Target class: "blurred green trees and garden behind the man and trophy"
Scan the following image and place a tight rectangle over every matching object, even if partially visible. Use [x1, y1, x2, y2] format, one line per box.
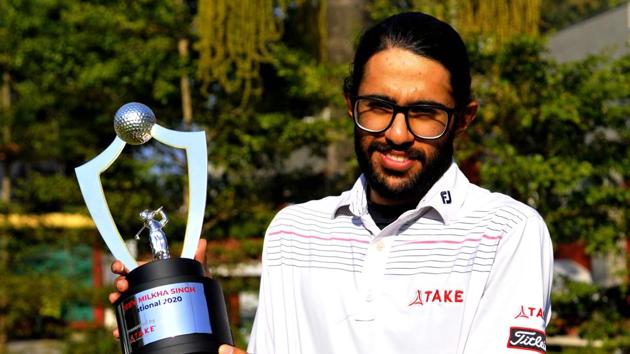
[0, 0, 630, 353]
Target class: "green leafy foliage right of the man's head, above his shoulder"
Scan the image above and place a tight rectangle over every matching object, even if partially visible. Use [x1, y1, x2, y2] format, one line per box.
[468, 38, 630, 251]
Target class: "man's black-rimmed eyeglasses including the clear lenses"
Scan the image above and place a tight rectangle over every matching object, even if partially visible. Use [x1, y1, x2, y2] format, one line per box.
[353, 96, 455, 139]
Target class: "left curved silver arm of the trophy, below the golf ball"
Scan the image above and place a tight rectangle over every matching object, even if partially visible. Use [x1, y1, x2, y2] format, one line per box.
[74, 137, 138, 271]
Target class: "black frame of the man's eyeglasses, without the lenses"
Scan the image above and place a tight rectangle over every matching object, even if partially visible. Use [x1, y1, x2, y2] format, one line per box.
[352, 96, 457, 140]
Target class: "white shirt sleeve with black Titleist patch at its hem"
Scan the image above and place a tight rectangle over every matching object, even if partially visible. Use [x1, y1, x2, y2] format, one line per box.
[463, 213, 553, 354]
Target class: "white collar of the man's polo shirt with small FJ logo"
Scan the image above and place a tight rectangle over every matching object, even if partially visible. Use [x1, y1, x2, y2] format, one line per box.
[331, 161, 470, 224]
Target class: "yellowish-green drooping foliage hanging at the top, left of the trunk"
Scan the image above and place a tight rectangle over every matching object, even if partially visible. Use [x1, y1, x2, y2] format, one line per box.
[196, 0, 326, 106]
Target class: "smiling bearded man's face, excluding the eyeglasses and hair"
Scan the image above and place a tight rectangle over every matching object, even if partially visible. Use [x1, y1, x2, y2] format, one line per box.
[349, 48, 455, 204]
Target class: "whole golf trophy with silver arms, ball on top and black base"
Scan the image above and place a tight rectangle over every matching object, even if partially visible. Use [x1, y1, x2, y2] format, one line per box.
[75, 102, 233, 354]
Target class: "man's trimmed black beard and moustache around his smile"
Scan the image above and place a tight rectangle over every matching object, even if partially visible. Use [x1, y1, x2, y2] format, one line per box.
[354, 128, 454, 202]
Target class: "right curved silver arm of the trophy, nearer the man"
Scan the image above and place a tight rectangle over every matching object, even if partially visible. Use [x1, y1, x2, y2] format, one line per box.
[151, 124, 208, 259]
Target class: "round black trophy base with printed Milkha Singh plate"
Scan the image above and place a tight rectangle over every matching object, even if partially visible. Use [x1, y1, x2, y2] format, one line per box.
[114, 258, 233, 354]
